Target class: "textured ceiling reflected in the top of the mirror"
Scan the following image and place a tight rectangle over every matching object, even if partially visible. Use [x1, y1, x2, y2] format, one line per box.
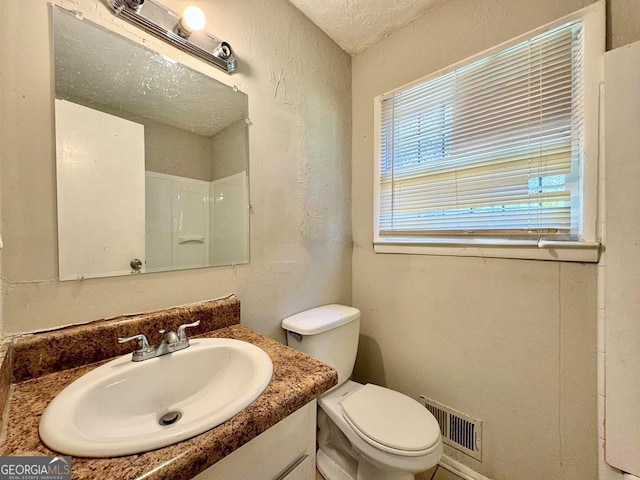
[54, 8, 248, 137]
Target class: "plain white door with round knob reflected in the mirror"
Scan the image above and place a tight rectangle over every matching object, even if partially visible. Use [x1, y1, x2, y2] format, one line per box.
[55, 99, 145, 280]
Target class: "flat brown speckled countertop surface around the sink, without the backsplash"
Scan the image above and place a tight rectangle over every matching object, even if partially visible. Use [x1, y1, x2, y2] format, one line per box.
[0, 297, 337, 480]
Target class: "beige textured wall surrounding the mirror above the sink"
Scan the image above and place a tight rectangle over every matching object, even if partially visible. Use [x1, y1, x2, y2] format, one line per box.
[0, 0, 351, 340]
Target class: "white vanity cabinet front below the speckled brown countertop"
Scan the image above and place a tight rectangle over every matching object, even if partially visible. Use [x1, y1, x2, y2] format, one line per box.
[194, 400, 316, 480]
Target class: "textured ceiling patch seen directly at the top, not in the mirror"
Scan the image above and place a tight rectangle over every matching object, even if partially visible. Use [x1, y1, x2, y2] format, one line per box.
[289, 0, 445, 55]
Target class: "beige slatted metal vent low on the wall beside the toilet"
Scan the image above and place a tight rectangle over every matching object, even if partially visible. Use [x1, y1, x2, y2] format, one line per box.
[420, 395, 482, 461]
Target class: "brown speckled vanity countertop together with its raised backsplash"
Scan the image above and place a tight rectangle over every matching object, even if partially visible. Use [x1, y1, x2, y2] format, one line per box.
[0, 297, 337, 480]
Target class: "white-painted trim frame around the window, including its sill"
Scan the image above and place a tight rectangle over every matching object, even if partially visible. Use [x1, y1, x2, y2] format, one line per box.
[373, 0, 605, 262]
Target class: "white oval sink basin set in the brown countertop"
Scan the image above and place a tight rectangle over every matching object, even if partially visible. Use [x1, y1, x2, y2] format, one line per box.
[40, 338, 273, 457]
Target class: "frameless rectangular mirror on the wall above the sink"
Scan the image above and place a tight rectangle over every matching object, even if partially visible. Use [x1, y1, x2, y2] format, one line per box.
[52, 6, 249, 280]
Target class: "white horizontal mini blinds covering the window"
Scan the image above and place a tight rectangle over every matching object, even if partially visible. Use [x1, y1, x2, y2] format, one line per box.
[378, 21, 584, 240]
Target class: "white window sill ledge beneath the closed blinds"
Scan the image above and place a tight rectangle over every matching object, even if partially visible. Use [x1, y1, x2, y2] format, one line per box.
[373, 238, 600, 263]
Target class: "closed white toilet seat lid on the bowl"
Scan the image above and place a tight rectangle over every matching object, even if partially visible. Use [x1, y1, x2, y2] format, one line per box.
[342, 383, 440, 455]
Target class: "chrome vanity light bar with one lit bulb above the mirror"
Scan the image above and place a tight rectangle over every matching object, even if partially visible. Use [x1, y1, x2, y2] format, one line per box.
[106, 0, 238, 73]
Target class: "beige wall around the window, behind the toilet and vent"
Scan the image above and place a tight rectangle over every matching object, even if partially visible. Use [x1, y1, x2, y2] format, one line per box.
[352, 0, 624, 480]
